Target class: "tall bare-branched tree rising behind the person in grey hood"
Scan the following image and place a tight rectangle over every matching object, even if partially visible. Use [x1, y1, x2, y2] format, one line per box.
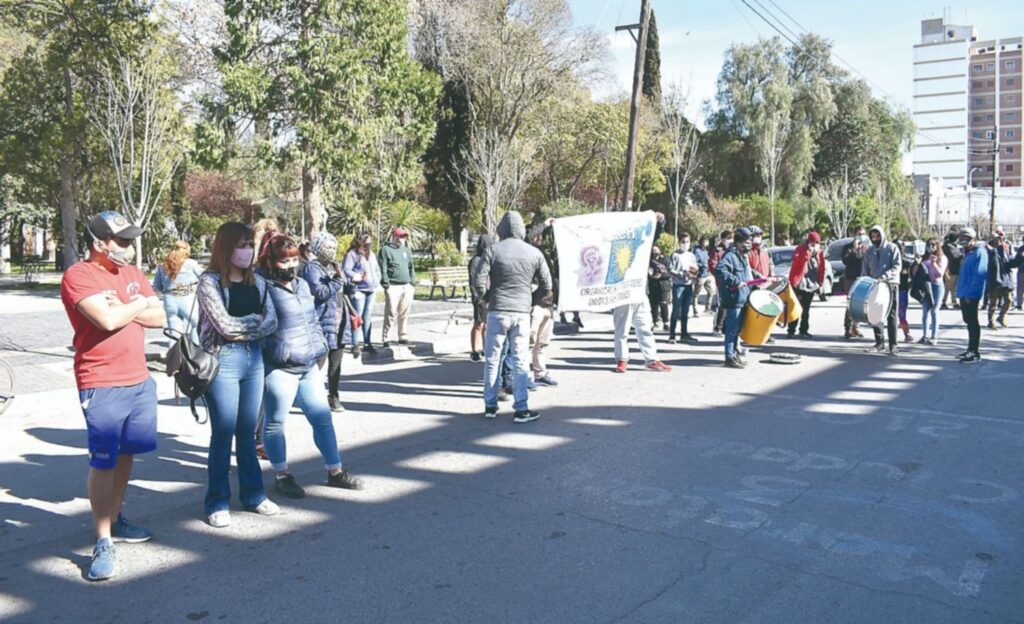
[415, 0, 604, 234]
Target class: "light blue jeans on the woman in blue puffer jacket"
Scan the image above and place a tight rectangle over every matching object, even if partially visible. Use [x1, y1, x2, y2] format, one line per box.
[263, 365, 341, 472]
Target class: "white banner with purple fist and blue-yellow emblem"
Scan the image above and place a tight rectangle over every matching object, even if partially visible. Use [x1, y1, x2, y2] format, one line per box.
[554, 211, 655, 311]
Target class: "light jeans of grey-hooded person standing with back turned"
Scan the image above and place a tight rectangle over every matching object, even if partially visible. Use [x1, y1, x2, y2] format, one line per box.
[483, 311, 529, 411]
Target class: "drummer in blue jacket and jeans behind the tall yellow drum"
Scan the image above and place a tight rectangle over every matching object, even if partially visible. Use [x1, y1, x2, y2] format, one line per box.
[715, 227, 754, 368]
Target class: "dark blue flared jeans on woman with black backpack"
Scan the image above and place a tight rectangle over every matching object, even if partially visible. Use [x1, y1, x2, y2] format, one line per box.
[205, 342, 266, 515]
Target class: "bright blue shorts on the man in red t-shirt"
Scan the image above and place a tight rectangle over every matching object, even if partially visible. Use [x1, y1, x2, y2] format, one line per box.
[78, 377, 157, 470]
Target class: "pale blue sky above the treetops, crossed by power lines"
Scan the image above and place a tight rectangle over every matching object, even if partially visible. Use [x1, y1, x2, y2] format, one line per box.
[568, 0, 1024, 125]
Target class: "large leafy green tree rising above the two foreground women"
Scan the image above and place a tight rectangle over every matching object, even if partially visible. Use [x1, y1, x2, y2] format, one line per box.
[217, 0, 438, 237]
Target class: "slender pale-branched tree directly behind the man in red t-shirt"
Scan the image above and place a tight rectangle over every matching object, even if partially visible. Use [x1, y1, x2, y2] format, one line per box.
[88, 49, 184, 267]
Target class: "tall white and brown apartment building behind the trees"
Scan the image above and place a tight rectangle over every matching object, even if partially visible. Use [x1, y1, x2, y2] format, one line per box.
[912, 18, 1024, 188]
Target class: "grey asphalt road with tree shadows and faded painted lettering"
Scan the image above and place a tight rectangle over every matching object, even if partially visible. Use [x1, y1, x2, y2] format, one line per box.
[0, 301, 1024, 623]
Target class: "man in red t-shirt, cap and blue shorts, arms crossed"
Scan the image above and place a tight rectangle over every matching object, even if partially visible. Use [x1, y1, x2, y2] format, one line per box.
[60, 211, 166, 581]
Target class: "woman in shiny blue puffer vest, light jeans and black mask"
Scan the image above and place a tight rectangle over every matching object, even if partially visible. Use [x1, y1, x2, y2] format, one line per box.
[260, 233, 359, 498]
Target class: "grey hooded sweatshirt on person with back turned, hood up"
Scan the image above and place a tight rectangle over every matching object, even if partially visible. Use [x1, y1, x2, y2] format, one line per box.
[472, 210, 551, 315]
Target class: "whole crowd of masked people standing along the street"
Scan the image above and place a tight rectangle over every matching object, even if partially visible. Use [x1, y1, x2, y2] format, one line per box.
[61, 211, 1024, 580]
